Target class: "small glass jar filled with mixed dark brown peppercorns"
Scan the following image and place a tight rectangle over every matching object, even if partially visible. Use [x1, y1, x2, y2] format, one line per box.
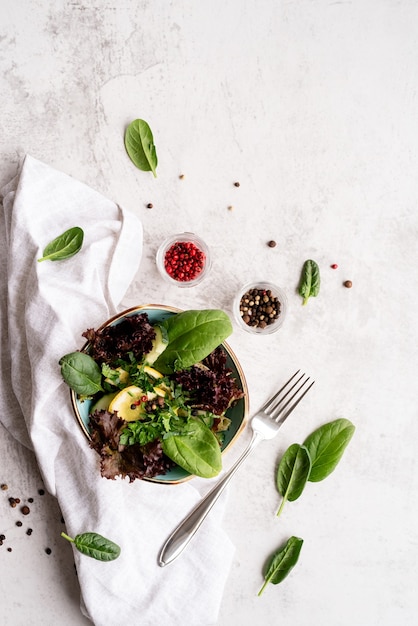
[233, 280, 288, 335]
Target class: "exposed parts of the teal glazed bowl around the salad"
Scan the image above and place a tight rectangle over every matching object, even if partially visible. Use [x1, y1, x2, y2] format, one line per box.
[71, 304, 249, 485]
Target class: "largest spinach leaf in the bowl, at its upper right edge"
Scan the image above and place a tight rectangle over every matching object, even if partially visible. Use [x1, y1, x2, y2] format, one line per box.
[153, 309, 232, 374]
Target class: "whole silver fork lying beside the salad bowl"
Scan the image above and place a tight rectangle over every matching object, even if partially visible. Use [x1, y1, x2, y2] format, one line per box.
[158, 370, 315, 567]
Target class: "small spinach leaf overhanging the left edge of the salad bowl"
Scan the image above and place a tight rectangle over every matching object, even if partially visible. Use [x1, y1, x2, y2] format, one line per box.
[59, 352, 104, 396]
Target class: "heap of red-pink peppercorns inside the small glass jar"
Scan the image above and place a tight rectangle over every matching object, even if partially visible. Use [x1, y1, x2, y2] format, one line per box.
[164, 241, 206, 282]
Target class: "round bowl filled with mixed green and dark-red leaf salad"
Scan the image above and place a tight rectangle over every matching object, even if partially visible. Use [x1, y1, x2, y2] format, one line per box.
[60, 304, 248, 484]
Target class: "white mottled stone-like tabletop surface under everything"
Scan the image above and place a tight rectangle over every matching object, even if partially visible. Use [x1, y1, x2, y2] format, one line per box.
[0, 0, 418, 626]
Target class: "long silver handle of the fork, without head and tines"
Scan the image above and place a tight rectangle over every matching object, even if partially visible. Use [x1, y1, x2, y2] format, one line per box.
[158, 433, 264, 567]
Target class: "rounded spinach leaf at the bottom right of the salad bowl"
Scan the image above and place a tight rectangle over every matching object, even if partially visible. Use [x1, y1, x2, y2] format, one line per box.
[162, 419, 222, 478]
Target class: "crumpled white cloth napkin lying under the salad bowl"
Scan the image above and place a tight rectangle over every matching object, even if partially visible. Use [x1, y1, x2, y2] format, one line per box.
[0, 156, 233, 626]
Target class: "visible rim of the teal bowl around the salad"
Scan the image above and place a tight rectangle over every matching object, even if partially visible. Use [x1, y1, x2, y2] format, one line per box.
[70, 304, 249, 485]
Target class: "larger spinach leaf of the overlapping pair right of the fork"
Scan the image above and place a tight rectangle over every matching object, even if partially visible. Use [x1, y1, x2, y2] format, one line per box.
[303, 418, 355, 482]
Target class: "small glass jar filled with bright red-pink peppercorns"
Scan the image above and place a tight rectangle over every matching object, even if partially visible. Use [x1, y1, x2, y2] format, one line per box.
[157, 233, 210, 287]
